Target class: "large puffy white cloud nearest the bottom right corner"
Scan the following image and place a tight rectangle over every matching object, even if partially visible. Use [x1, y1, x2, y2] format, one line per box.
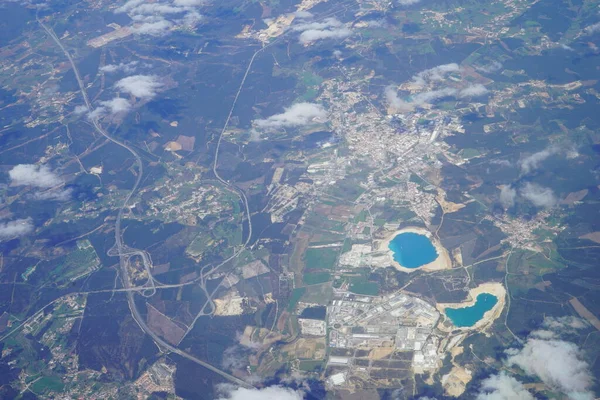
[506, 335, 593, 400]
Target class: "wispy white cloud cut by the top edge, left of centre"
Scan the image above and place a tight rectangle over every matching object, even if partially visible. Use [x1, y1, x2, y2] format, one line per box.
[115, 0, 205, 36]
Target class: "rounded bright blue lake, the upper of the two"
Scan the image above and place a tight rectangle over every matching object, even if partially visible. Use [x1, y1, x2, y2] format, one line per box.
[388, 232, 438, 268]
